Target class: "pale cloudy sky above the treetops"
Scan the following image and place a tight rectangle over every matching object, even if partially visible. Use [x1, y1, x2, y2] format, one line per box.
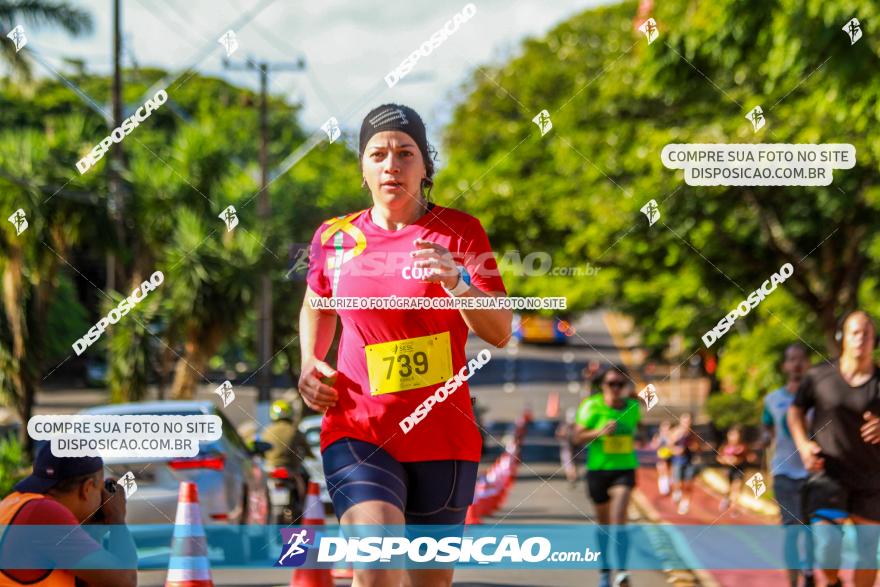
[20, 0, 607, 154]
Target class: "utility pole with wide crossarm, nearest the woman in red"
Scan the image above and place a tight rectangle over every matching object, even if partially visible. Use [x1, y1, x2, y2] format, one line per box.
[223, 58, 305, 425]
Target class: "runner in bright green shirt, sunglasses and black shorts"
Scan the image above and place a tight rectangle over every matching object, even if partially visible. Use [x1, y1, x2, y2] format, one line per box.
[572, 367, 641, 587]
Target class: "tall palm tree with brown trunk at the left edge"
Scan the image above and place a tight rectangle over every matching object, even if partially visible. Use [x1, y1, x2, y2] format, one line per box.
[0, 116, 101, 454]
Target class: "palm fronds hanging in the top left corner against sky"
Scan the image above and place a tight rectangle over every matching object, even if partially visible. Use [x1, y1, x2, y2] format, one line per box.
[0, 0, 92, 78]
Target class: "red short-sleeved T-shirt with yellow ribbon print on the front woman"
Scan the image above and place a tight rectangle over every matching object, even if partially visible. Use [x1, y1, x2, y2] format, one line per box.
[308, 206, 506, 462]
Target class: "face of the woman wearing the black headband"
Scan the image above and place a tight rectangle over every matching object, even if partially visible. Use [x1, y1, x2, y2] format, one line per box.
[362, 131, 426, 210]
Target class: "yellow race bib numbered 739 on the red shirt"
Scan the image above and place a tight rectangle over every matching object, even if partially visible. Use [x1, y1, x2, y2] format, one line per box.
[364, 332, 452, 395]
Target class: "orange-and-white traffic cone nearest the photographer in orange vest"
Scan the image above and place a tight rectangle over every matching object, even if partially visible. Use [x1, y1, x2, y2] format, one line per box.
[165, 481, 214, 587]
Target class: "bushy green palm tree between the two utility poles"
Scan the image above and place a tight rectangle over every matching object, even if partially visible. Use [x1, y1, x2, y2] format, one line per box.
[108, 120, 266, 401]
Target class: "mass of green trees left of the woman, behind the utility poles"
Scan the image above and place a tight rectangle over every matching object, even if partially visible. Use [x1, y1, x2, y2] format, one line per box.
[0, 62, 369, 414]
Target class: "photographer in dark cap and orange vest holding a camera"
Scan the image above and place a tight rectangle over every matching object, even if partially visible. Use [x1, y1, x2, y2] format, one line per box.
[0, 443, 137, 587]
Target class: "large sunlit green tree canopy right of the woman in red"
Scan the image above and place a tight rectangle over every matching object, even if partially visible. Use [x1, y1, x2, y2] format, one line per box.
[438, 0, 880, 395]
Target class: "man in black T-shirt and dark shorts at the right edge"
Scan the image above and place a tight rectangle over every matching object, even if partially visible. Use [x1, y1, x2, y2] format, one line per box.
[788, 311, 880, 587]
